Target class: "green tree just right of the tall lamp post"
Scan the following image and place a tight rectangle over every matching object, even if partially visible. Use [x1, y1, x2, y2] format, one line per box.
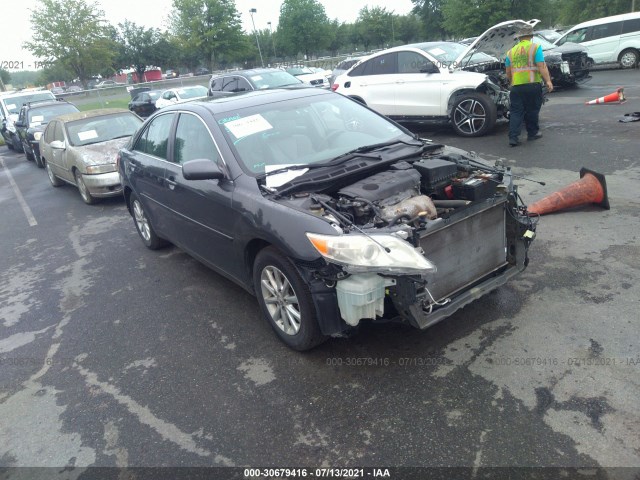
[278, 0, 330, 58]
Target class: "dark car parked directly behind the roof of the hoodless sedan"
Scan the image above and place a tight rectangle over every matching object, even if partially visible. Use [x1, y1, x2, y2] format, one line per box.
[208, 68, 308, 97]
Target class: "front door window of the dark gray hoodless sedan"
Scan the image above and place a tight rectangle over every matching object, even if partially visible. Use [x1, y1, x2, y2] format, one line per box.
[173, 113, 222, 167]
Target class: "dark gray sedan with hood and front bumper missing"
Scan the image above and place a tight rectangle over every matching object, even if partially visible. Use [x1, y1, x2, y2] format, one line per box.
[119, 88, 535, 350]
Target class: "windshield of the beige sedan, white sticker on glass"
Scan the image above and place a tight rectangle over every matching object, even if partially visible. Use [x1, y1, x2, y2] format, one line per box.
[65, 112, 142, 147]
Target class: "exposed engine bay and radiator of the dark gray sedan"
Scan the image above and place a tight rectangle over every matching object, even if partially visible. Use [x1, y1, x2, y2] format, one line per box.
[268, 145, 535, 334]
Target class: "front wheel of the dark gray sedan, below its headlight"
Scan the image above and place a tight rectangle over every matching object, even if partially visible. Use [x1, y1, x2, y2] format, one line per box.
[253, 247, 327, 351]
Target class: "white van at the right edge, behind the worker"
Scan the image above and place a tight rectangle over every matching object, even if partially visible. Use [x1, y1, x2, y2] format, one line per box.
[555, 12, 640, 68]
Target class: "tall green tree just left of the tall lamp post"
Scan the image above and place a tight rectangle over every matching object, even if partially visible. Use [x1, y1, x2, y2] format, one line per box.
[169, 0, 249, 69]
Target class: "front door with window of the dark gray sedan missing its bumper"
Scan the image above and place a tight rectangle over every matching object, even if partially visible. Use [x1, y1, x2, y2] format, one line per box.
[165, 112, 242, 278]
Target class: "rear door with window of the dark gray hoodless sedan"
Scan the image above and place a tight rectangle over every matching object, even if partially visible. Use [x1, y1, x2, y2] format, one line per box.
[124, 112, 177, 233]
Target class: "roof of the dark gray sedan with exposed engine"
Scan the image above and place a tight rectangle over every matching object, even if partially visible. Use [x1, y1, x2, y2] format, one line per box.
[161, 88, 340, 115]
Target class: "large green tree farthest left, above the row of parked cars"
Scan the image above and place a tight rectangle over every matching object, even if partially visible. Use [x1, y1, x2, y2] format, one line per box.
[24, 0, 116, 85]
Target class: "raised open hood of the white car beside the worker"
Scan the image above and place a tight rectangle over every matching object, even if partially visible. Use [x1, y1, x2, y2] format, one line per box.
[455, 19, 540, 69]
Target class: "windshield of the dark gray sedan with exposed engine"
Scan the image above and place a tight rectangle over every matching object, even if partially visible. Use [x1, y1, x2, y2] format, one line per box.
[216, 94, 415, 176]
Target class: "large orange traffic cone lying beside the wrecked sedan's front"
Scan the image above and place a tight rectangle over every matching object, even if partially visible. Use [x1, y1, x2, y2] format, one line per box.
[527, 168, 609, 215]
